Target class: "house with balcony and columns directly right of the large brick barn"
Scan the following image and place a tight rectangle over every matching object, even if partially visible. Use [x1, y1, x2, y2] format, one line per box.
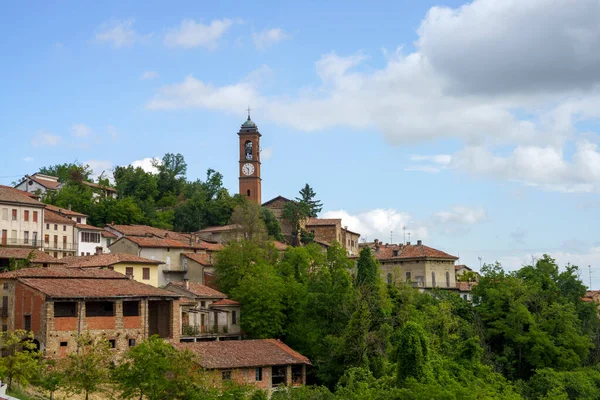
[165, 280, 242, 342]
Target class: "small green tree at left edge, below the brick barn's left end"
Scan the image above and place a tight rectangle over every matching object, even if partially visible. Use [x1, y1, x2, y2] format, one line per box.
[0, 329, 41, 388]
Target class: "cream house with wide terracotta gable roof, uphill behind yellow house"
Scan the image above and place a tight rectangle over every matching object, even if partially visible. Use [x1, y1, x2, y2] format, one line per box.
[110, 232, 223, 286]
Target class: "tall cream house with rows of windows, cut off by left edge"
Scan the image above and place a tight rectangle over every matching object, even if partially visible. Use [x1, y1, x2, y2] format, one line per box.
[0, 185, 45, 249]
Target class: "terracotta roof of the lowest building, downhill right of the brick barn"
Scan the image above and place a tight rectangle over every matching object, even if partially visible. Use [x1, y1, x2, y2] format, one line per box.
[173, 339, 310, 369]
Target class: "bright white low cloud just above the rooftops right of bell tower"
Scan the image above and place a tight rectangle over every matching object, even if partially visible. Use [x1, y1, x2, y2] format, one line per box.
[320, 208, 429, 243]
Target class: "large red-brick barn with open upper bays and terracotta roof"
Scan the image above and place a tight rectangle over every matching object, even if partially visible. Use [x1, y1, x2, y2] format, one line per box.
[0, 267, 179, 357]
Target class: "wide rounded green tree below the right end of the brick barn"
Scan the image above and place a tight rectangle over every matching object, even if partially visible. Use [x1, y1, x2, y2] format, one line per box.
[113, 336, 197, 400]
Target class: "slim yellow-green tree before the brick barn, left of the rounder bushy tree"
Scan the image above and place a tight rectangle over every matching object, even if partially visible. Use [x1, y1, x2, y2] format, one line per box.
[65, 333, 112, 400]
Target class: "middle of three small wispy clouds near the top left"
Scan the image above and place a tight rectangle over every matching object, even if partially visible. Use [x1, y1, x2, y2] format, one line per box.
[164, 19, 234, 49]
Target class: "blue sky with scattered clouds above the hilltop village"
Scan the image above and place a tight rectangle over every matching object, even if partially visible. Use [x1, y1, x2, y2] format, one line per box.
[0, 0, 600, 289]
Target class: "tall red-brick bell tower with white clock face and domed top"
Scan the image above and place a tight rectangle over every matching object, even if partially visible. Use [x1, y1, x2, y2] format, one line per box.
[238, 108, 262, 205]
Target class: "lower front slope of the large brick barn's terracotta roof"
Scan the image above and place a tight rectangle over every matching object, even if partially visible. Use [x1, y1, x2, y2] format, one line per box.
[19, 275, 179, 299]
